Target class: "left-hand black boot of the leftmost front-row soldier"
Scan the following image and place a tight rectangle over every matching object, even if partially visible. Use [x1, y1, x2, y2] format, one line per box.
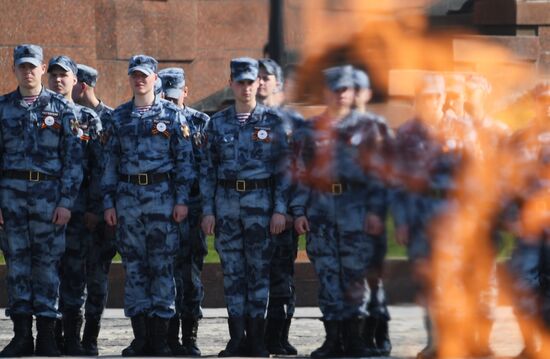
[0, 315, 34, 358]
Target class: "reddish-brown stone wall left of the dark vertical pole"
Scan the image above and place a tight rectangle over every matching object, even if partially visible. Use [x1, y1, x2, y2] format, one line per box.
[0, 0, 269, 105]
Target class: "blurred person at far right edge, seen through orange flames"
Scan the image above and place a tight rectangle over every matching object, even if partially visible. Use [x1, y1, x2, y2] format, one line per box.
[508, 82, 550, 359]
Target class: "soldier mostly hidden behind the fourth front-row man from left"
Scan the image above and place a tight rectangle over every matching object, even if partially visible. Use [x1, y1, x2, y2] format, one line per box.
[353, 69, 393, 356]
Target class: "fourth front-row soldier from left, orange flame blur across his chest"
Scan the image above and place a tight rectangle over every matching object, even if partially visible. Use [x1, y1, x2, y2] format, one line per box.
[293, 65, 385, 358]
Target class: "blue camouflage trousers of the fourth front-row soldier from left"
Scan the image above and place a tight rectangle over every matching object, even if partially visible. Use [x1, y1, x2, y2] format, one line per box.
[306, 191, 373, 320]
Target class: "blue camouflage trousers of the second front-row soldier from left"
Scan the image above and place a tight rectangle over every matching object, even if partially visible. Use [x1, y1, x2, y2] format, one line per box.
[116, 181, 179, 319]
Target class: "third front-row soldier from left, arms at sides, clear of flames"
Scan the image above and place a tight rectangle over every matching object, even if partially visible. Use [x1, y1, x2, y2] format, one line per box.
[200, 57, 290, 357]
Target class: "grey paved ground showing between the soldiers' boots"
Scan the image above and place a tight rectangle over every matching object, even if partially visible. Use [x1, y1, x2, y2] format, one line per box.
[0, 306, 522, 358]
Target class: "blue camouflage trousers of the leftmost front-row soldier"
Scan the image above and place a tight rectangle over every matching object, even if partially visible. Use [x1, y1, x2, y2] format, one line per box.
[0, 179, 65, 318]
